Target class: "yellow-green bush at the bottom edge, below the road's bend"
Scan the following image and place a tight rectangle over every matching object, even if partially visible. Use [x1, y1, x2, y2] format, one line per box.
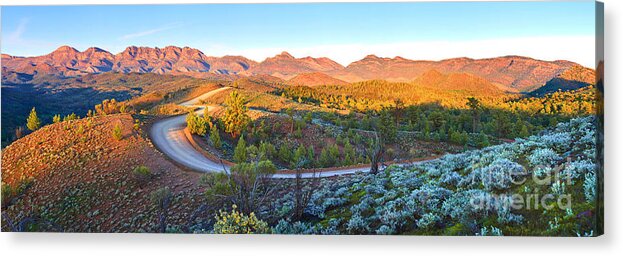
[214, 205, 270, 234]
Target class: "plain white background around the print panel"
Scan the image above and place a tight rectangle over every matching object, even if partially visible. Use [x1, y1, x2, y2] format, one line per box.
[0, 0, 623, 256]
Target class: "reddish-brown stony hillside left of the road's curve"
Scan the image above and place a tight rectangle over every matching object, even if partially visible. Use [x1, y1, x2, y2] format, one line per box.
[2, 115, 202, 232]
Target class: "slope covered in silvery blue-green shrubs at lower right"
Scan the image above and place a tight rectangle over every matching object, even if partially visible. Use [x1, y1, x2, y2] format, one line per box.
[265, 117, 603, 237]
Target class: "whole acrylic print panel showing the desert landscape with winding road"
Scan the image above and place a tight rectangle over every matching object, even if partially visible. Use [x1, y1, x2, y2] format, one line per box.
[1, 1, 604, 236]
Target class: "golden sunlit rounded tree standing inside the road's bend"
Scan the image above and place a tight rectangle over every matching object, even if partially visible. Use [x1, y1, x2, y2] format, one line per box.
[223, 91, 250, 138]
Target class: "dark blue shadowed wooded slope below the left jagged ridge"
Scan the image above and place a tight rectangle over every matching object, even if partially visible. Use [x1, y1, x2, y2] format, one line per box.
[1, 72, 219, 146]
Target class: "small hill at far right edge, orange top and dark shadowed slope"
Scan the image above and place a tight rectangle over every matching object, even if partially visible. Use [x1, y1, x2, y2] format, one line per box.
[530, 65, 596, 96]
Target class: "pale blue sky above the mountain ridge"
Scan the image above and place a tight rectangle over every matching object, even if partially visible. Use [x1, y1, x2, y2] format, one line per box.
[0, 1, 595, 67]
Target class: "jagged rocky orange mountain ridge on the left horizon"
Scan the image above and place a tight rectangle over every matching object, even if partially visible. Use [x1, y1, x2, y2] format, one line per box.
[2, 46, 256, 80]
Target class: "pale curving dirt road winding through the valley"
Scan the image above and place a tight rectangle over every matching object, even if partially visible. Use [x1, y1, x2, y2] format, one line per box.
[149, 87, 430, 179]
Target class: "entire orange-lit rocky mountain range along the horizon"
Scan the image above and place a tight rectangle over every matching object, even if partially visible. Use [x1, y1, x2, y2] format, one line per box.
[1, 46, 594, 92]
